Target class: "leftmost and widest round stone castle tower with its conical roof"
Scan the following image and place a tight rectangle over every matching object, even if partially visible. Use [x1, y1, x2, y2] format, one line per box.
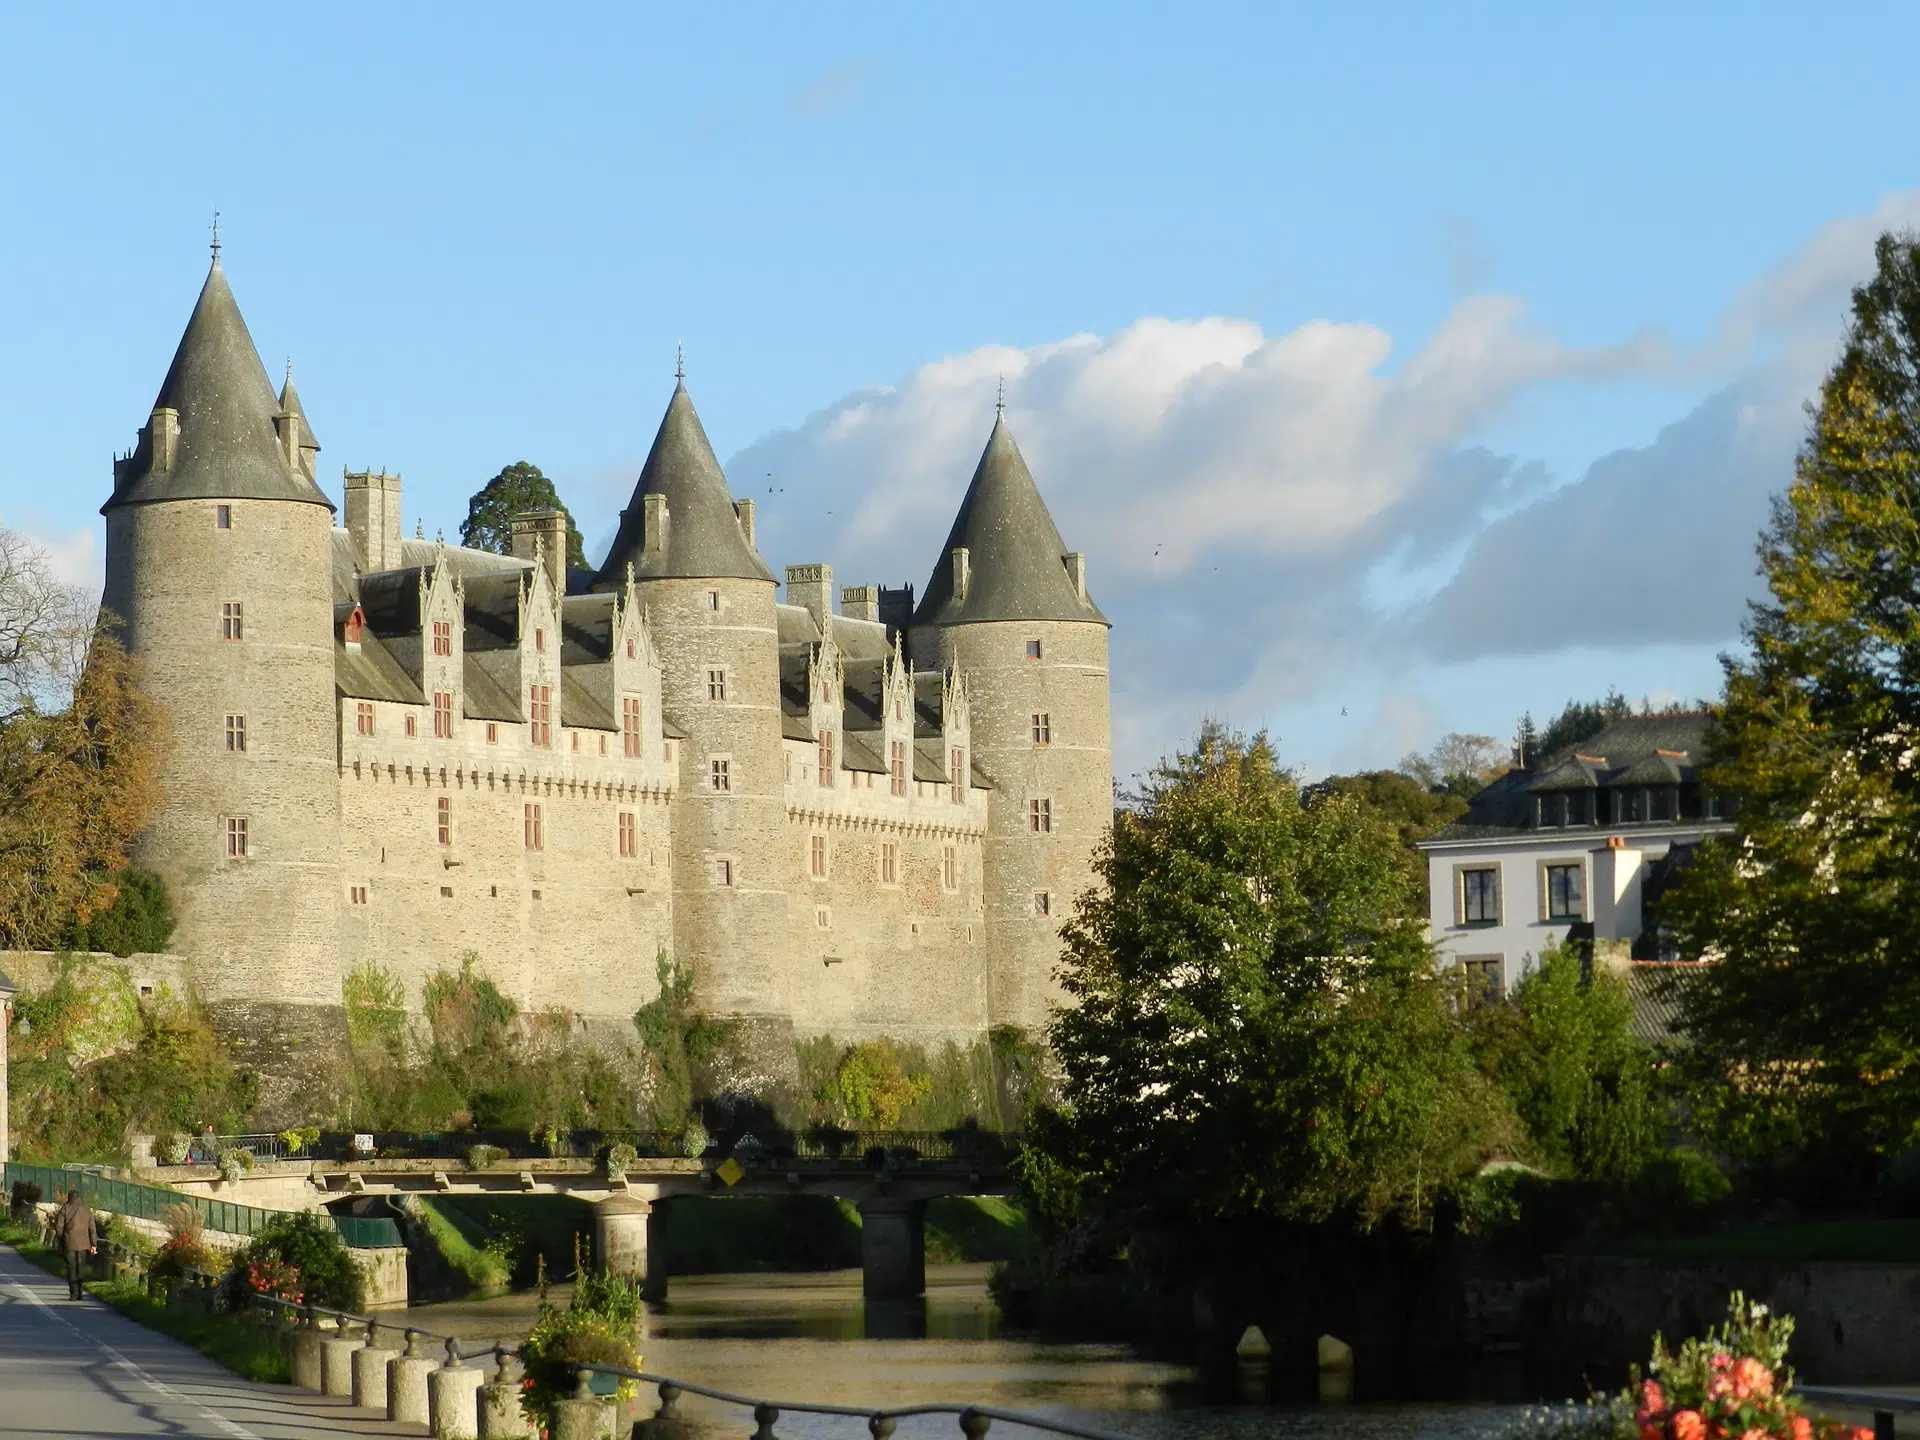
[102, 248, 340, 1119]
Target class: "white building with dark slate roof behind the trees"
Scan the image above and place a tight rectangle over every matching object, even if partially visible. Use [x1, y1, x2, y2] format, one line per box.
[1421, 712, 1732, 996]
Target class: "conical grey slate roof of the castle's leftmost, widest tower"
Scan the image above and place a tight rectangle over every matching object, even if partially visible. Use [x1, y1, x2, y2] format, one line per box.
[100, 257, 334, 511]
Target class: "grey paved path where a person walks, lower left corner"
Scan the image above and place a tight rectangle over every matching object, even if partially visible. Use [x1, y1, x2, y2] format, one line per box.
[0, 1246, 426, 1440]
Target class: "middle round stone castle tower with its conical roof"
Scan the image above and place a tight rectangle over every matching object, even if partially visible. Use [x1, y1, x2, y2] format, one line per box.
[593, 382, 791, 1066]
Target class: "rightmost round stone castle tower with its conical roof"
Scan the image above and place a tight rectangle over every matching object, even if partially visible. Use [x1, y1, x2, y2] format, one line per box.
[910, 415, 1114, 1031]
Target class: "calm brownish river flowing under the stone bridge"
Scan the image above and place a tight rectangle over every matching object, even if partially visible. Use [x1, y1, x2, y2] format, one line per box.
[396, 1265, 1517, 1440]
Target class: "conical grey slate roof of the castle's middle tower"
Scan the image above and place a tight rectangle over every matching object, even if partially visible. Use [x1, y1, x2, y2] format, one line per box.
[593, 382, 774, 586]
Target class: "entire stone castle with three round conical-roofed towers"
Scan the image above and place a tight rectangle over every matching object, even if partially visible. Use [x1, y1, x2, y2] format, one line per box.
[102, 248, 1112, 1110]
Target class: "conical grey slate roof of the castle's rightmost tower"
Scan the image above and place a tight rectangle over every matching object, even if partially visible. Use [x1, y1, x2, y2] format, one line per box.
[912, 415, 1108, 626]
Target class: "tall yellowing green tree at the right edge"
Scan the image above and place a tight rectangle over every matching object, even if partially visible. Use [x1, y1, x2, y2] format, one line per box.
[1663, 234, 1920, 1183]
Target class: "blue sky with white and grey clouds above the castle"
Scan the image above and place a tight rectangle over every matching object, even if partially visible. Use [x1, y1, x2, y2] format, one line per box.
[0, 4, 1920, 780]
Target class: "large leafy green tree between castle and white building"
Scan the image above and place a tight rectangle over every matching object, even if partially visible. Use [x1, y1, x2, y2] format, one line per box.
[1025, 724, 1513, 1229]
